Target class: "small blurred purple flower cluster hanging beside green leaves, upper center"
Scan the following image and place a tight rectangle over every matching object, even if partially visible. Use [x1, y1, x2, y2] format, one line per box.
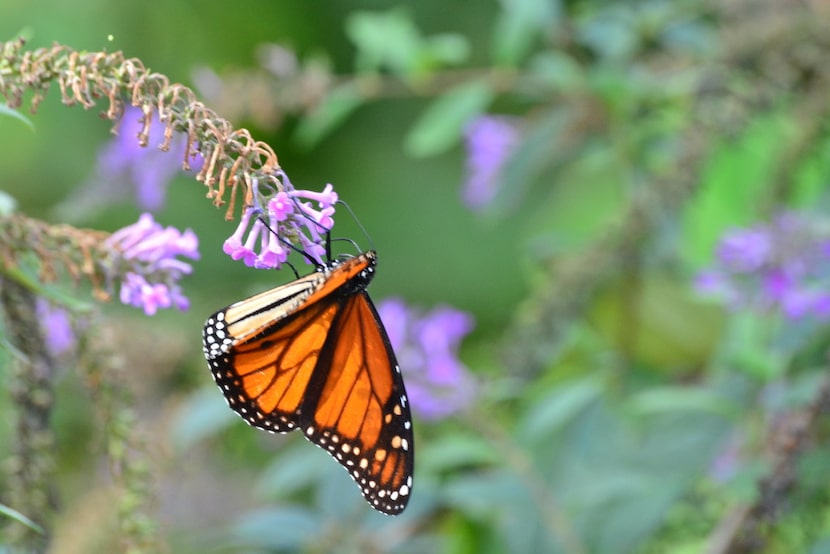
[462, 116, 519, 210]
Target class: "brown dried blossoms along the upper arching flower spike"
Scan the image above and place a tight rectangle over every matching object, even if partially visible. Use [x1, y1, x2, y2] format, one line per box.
[0, 39, 281, 219]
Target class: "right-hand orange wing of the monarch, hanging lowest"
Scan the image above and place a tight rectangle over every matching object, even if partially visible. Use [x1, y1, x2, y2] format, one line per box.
[302, 291, 414, 514]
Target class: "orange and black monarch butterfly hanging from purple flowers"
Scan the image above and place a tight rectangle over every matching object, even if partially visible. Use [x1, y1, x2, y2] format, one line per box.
[202, 250, 414, 515]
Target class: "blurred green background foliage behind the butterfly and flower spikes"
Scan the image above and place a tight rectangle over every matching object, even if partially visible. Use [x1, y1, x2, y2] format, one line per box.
[0, 0, 830, 553]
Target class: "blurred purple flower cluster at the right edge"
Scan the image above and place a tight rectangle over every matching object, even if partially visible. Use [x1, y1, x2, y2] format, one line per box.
[696, 212, 830, 320]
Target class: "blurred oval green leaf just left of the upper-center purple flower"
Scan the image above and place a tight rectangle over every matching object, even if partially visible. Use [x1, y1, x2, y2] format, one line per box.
[404, 81, 493, 157]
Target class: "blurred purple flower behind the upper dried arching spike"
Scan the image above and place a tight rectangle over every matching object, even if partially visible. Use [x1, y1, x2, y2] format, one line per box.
[72, 106, 203, 215]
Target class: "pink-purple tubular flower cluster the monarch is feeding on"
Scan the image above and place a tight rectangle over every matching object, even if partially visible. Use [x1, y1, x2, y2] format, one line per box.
[223, 170, 337, 269]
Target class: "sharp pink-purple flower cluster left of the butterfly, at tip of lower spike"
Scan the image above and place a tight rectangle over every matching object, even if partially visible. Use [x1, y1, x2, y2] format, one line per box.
[106, 213, 199, 315]
